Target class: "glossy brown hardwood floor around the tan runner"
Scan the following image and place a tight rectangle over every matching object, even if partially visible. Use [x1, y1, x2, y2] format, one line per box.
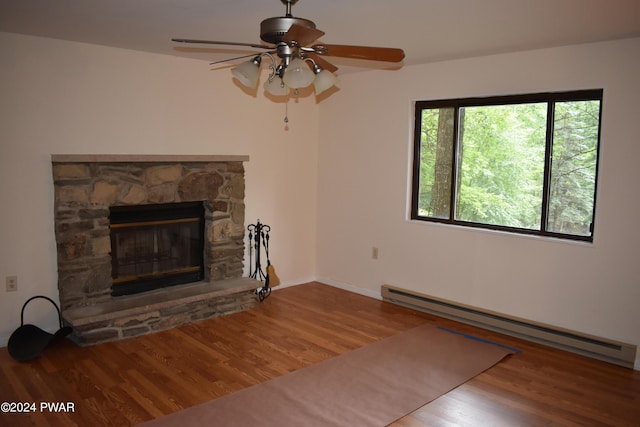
[0, 283, 640, 427]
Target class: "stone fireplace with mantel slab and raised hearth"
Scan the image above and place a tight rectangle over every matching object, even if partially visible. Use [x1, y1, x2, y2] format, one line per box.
[52, 155, 259, 344]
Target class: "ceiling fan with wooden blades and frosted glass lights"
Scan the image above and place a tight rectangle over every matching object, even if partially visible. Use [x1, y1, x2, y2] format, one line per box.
[171, 0, 404, 95]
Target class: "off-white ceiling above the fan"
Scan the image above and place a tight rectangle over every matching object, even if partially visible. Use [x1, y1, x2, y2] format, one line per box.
[0, 0, 640, 73]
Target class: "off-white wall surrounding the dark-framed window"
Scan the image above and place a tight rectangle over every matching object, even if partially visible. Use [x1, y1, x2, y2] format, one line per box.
[318, 39, 640, 368]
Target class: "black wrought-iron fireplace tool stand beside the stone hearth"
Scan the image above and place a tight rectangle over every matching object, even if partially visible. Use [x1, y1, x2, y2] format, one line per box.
[247, 219, 280, 301]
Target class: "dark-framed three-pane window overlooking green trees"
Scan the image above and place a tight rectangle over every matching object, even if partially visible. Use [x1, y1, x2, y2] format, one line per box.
[411, 89, 602, 241]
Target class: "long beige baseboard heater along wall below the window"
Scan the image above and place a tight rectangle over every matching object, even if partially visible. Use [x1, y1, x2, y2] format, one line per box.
[381, 285, 637, 369]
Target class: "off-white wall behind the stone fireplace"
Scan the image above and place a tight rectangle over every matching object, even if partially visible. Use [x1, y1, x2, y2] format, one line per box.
[0, 33, 317, 345]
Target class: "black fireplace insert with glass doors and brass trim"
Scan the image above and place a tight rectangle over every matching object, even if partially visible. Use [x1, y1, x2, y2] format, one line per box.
[109, 202, 204, 296]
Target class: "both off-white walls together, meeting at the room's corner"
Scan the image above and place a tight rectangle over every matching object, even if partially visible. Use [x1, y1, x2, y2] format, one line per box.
[0, 33, 640, 368]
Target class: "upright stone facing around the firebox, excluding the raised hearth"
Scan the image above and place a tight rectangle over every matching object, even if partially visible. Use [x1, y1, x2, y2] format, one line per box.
[52, 155, 248, 312]
